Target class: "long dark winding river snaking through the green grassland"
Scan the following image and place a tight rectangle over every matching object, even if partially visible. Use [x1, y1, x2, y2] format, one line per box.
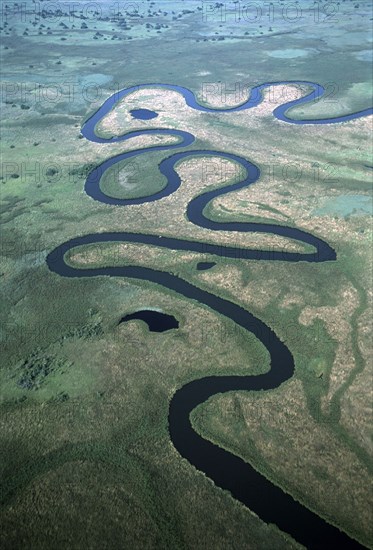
[47, 82, 372, 548]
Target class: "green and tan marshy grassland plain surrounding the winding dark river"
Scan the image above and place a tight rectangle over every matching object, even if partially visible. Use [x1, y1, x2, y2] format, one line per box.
[0, 2, 372, 550]
